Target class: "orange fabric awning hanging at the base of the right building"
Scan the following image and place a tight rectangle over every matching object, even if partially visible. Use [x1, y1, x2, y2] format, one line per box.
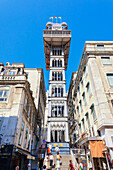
[89, 141, 105, 158]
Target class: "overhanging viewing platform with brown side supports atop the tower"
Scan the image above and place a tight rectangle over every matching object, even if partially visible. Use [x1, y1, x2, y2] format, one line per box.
[43, 22, 71, 70]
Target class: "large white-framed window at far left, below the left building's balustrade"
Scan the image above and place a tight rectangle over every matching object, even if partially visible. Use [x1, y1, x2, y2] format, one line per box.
[0, 86, 9, 101]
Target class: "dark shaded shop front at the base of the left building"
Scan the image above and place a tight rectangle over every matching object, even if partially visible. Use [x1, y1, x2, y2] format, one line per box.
[0, 145, 35, 170]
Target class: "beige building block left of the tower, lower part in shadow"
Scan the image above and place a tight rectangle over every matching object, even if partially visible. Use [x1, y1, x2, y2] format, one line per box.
[0, 63, 46, 170]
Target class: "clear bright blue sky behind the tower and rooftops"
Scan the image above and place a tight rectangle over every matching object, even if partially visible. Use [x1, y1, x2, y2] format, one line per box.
[0, 0, 113, 90]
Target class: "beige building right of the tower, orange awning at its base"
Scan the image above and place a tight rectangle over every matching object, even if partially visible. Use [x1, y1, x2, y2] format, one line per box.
[69, 41, 113, 169]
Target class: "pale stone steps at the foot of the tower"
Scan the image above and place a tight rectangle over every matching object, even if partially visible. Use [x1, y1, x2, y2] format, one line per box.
[54, 155, 72, 170]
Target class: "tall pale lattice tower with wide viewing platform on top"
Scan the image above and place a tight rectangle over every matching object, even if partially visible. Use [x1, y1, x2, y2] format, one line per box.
[43, 22, 71, 149]
